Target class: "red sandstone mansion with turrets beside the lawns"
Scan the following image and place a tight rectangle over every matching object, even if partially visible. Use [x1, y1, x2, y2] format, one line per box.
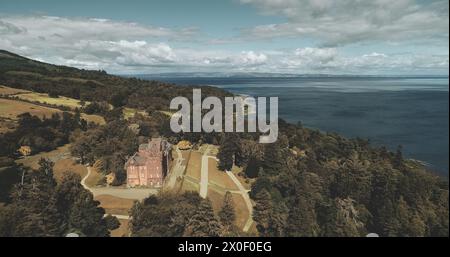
[125, 138, 171, 187]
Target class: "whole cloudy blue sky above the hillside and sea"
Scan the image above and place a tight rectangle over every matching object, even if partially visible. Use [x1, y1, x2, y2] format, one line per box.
[0, 0, 449, 75]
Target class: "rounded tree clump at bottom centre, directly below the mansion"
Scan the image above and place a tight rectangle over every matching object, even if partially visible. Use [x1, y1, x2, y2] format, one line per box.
[130, 192, 239, 237]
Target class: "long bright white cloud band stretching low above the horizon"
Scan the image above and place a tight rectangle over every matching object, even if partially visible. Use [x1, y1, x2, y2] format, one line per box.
[0, 14, 448, 74]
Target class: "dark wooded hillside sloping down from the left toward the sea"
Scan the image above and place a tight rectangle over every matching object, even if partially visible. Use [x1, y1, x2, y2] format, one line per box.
[0, 50, 229, 110]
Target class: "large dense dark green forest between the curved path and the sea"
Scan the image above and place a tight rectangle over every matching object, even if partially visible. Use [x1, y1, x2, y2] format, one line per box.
[246, 122, 449, 236]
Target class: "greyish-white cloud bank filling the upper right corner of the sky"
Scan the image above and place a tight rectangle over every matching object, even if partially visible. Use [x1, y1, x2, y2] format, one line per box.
[237, 0, 449, 46]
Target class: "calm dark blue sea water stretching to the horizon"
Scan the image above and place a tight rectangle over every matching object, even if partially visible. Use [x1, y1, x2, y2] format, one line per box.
[142, 77, 449, 176]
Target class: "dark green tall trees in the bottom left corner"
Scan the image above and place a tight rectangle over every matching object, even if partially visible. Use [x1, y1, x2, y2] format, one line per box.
[0, 159, 109, 236]
